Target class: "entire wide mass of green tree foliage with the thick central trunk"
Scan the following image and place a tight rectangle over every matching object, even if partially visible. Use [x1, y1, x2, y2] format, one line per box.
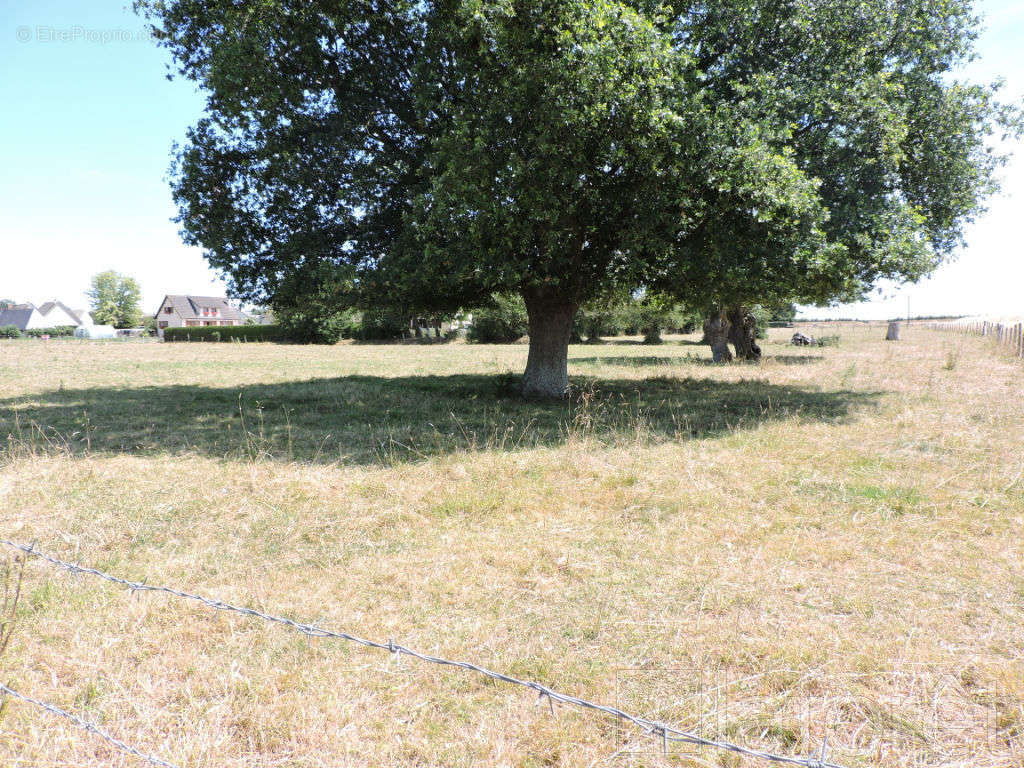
[137, 0, 1017, 395]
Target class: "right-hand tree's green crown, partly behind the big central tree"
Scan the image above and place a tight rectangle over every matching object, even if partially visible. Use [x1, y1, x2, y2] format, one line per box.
[647, 0, 1020, 315]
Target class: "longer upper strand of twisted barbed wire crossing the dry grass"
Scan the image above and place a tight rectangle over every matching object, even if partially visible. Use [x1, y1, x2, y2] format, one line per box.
[0, 539, 844, 768]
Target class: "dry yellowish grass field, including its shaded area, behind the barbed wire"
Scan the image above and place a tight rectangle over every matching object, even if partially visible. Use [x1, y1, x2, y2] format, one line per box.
[0, 325, 1024, 768]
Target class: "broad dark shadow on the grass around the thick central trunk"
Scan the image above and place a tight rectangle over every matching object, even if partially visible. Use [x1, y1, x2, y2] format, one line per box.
[0, 375, 879, 464]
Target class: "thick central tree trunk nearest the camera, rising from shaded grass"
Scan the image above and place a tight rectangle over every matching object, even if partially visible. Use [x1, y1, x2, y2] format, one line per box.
[522, 289, 577, 397]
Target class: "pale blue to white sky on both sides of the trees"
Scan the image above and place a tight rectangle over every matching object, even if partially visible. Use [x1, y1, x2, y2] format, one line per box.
[0, 0, 1024, 317]
